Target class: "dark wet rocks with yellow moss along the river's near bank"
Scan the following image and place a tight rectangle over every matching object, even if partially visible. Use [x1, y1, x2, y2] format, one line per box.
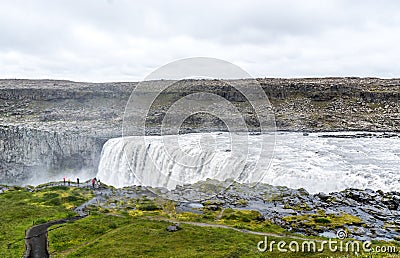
[164, 180, 400, 240]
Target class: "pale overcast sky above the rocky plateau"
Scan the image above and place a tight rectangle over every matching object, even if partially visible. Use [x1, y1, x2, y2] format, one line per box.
[0, 0, 400, 82]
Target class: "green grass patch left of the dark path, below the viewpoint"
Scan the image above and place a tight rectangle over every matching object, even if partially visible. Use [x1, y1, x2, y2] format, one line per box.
[0, 187, 91, 257]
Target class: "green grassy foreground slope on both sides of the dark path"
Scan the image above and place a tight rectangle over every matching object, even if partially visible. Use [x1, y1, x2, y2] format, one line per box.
[0, 187, 400, 257]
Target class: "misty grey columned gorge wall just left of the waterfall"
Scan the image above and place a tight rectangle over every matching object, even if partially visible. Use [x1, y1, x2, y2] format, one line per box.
[0, 126, 103, 184]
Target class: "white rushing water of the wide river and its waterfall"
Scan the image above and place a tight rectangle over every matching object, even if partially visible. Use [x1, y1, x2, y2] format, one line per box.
[97, 132, 400, 193]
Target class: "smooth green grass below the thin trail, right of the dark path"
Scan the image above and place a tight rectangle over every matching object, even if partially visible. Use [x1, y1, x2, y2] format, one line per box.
[49, 214, 400, 258]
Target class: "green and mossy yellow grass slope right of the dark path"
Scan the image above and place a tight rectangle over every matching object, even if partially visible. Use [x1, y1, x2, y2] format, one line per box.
[49, 200, 400, 257]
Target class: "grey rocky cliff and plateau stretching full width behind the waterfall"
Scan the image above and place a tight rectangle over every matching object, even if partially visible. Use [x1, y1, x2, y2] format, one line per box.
[0, 78, 400, 183]
